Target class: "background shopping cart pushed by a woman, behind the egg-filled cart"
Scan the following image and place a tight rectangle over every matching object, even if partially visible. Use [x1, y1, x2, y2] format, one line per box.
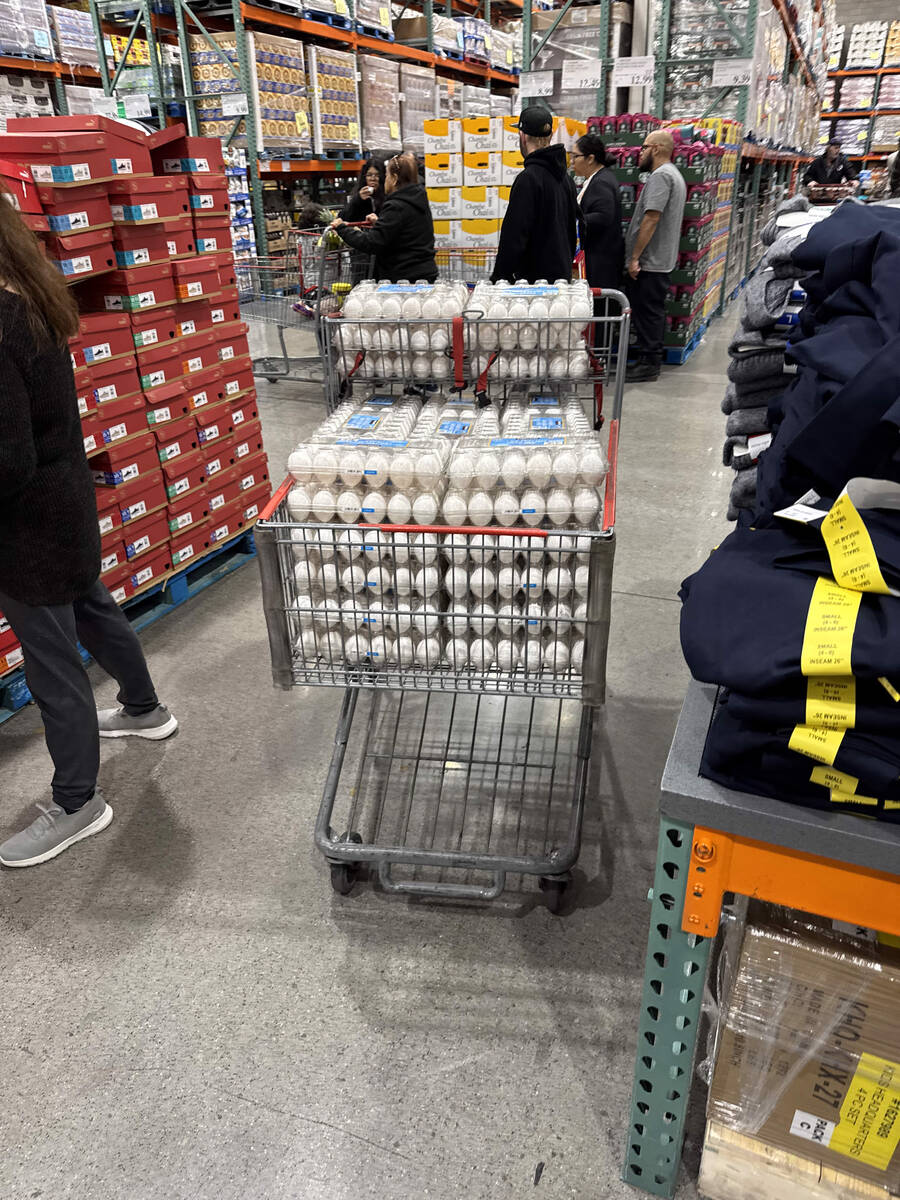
[236, 228, 371, 385]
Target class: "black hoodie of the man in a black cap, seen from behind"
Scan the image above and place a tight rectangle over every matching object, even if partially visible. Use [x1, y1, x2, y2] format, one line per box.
[491, 145, 578, 283]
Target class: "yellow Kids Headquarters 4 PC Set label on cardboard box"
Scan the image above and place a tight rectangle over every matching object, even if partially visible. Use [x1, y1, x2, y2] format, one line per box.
[829, 1054, 900, 1171]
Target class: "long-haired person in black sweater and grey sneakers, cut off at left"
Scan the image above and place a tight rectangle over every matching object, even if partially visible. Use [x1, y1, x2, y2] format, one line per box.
[0, 197, 178, 866]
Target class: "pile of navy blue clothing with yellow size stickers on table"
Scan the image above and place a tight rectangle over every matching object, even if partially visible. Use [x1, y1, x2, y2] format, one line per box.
[682, 204, 900, 822]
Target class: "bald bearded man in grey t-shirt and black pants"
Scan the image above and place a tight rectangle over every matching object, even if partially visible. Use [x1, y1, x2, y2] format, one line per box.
[625, 130, 688, 383]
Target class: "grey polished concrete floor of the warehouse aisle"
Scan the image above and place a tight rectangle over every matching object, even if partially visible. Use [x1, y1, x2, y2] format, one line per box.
[0, 319, 733, 1200]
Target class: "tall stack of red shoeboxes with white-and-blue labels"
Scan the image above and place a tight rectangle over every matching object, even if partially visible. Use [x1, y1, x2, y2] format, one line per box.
[0, 116, 270, 609]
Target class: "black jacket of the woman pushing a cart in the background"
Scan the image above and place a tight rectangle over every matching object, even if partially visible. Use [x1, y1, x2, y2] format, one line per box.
[337, 184, 438, 283]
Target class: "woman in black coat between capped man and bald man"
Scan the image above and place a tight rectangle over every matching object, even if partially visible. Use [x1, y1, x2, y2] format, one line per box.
[571, 133, 625, 288]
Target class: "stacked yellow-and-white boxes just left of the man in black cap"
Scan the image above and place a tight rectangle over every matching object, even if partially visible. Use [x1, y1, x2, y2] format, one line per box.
[425, 116, 522, 250]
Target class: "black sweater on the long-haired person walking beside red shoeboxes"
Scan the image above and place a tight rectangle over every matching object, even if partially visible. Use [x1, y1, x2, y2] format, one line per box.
[0, 288, 100, 606]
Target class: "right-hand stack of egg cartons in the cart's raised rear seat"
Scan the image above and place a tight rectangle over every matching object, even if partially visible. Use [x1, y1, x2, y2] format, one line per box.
[466, 280, 594, 383]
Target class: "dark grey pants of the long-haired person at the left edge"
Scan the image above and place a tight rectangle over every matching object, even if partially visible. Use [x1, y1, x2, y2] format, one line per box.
[0, 581, 158, 812]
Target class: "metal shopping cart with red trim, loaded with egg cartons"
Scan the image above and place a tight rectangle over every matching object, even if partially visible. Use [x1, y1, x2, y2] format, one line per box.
[257, 293, 630, 912]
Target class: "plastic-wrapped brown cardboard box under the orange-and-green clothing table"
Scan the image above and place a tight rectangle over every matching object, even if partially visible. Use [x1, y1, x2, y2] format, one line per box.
[709, 905, 900, 1190]
